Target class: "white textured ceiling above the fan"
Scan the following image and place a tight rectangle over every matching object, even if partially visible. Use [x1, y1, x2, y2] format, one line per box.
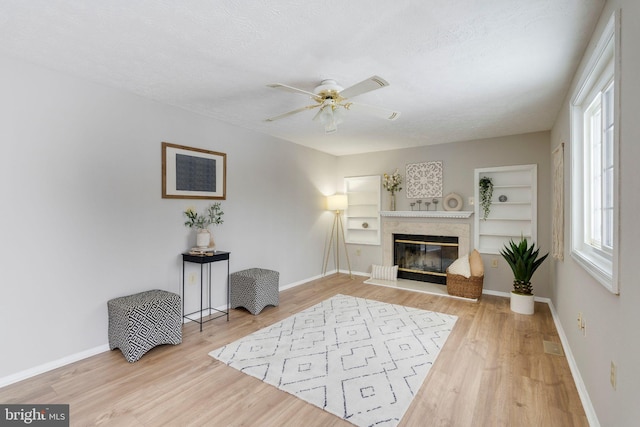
[0, 0, 604, 155]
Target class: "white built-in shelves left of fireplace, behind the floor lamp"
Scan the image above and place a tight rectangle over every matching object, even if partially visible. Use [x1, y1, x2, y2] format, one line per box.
[344, 175, 381, 245]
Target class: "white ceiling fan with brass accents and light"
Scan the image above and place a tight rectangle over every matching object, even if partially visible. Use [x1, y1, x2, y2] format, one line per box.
[266, 76, 400, 133]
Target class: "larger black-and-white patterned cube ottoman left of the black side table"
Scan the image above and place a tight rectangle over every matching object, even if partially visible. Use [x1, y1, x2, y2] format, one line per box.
[107, 289, 182, 362]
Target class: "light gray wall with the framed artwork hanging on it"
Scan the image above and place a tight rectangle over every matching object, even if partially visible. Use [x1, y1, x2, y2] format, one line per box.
[0, 57, 336, 379]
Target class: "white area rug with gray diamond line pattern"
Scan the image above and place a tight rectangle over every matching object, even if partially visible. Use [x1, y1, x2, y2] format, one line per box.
[209, 295, 457, 426]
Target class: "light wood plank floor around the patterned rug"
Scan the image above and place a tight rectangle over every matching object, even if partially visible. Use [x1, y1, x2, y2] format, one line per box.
[0, 275, 588, 427]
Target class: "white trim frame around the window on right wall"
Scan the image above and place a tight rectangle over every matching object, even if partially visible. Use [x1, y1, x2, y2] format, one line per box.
[570, 10, 620, 294]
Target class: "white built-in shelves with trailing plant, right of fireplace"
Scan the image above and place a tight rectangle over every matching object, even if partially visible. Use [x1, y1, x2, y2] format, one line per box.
[474, 165, 538, 254]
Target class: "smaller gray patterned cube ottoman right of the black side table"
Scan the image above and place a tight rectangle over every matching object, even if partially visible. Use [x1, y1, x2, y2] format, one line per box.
[231, 268, 280, 315]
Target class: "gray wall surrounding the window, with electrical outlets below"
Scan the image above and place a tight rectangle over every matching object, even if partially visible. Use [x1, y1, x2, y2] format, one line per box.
[550, 0, 640, 427]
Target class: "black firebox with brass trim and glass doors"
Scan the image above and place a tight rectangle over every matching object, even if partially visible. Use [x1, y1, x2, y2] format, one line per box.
[393, 234, 458, 285]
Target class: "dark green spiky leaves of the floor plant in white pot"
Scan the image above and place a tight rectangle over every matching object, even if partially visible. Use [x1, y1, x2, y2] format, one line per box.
[500, 237, 549, 295]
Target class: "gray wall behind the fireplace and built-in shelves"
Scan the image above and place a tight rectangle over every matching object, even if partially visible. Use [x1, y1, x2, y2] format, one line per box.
[337, 132, 551, 297]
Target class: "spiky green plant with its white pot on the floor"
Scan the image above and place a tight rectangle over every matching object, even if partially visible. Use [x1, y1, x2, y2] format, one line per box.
[500, 237, 549, 314]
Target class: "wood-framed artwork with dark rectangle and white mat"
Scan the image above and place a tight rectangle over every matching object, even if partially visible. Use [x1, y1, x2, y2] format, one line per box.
[162, 142, 227, 200]
